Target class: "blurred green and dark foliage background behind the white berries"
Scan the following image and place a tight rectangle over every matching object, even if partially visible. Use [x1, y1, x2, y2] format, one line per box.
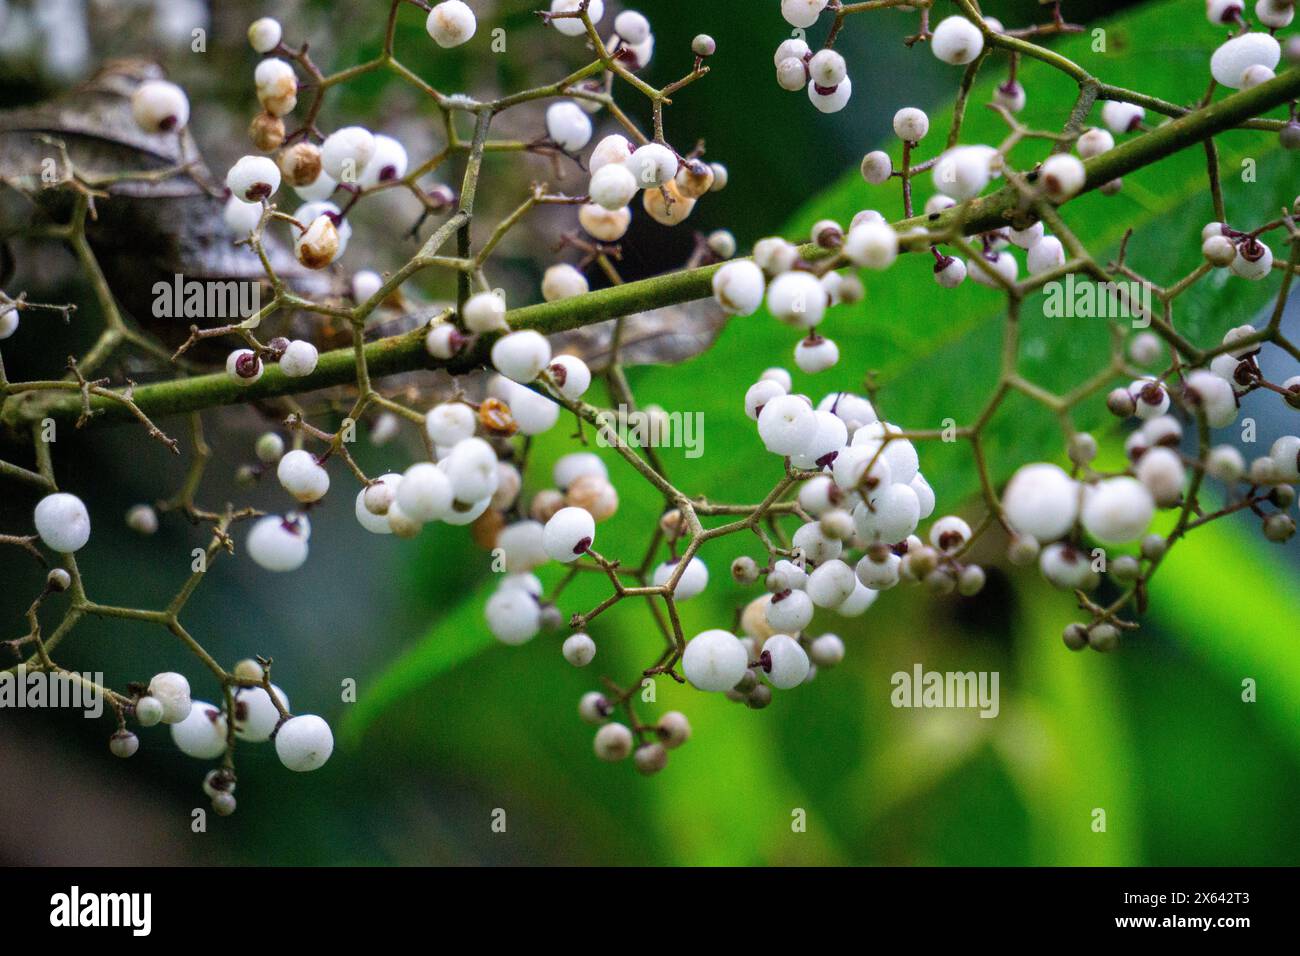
[0, 0, 1300, 865]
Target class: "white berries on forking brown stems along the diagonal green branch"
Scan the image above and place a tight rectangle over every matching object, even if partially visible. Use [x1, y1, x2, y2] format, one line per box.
[0, 0, 1300, 813]
